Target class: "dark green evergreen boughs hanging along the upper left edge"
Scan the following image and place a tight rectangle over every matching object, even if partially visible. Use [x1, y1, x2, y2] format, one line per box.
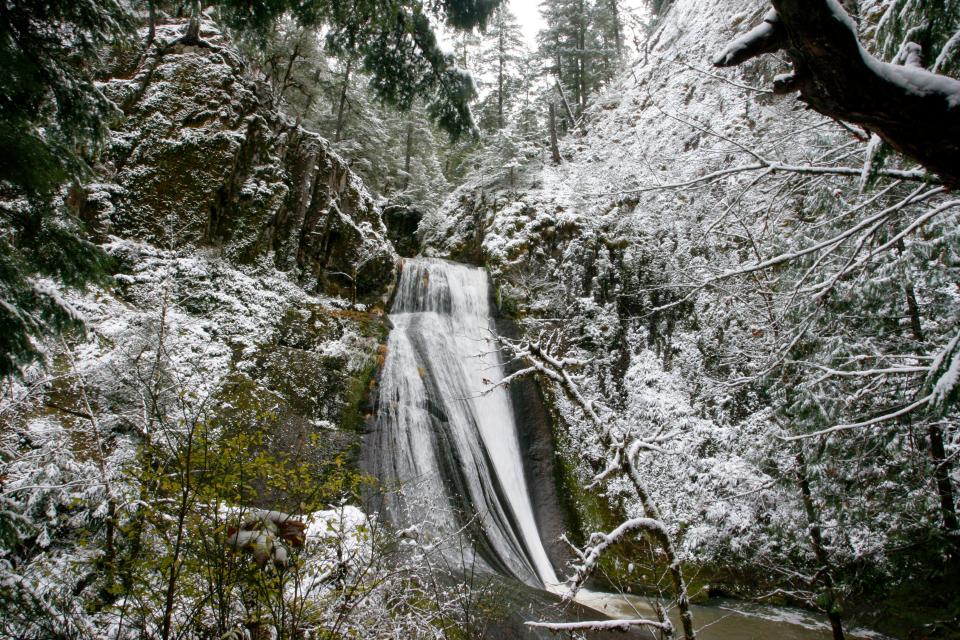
[0, 0, 130, 376]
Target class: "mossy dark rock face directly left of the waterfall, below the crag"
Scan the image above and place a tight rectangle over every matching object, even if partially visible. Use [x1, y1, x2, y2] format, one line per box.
[215, 304, 387, 508]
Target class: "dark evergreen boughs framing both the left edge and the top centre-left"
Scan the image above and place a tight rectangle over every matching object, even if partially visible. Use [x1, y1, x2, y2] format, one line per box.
[0, 0, 500, 376]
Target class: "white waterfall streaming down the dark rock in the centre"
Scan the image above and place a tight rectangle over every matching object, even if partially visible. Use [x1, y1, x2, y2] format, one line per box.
[369, 259, 558, 588]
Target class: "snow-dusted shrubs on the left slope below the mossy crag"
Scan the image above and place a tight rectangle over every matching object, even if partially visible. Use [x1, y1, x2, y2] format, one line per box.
[0, 238, 390, 637]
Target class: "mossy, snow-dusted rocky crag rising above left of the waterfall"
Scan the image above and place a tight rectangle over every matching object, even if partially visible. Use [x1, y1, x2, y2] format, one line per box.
[95, 23, 396, 301]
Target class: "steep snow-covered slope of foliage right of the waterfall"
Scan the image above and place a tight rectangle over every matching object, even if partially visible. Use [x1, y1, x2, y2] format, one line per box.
[420, 0, 960, 624]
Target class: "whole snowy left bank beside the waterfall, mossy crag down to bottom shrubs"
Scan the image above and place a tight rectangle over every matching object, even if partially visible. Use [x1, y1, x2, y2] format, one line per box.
[0, 16, 414, 639]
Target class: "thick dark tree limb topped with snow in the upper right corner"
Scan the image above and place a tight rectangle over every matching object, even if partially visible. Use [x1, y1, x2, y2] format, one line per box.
[714, 0, 960, 187]
